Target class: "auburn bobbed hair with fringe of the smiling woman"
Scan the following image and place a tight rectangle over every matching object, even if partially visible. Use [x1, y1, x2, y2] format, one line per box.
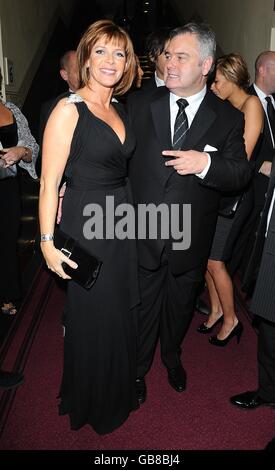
[76, 20, 136, 96]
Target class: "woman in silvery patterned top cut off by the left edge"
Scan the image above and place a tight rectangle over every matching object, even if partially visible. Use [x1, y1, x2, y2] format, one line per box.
[0, 70, 39, 315]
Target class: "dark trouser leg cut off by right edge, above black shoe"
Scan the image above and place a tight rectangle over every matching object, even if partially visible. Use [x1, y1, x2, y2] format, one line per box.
[258, 319, 275, 402]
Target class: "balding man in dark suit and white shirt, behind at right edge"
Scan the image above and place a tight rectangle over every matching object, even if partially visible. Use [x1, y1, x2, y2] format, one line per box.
[228, 51, 275, 280]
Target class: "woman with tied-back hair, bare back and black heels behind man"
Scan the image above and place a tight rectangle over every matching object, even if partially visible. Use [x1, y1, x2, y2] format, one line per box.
[198, 53, 264, 346]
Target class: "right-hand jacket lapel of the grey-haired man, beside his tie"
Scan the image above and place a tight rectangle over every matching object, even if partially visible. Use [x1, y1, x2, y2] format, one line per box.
[182, 92, 217, 150]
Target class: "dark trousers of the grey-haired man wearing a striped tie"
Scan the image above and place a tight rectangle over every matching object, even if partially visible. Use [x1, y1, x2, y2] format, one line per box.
[137, 252, 204, 377]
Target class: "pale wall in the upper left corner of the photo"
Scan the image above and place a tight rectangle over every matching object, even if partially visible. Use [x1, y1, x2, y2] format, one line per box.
[0, 0, 75, 104]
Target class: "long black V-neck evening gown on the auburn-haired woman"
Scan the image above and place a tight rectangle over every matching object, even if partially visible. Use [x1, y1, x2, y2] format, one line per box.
[59, 95, 139, 434]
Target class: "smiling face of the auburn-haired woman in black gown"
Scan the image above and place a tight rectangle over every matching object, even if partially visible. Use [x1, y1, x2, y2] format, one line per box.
[86, 36, 126, 88]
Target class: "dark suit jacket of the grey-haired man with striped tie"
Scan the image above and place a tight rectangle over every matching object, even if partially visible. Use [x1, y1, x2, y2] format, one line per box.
[128, 87, 251, 274]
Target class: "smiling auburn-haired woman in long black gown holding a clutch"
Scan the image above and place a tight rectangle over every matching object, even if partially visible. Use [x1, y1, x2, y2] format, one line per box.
[40, 20, 139, 434]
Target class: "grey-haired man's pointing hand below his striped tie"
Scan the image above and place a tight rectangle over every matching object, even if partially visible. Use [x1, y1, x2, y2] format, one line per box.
[162, 150, 208, 175]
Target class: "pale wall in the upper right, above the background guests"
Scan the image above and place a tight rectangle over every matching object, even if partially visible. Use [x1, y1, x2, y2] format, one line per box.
[171, 0, 275, 78]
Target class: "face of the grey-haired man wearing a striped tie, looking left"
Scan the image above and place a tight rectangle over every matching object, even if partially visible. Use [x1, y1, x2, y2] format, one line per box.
[164, 33, 212, 97]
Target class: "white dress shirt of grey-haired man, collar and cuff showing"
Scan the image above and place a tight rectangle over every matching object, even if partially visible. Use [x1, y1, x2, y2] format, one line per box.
[170, 85, 211, 179]
